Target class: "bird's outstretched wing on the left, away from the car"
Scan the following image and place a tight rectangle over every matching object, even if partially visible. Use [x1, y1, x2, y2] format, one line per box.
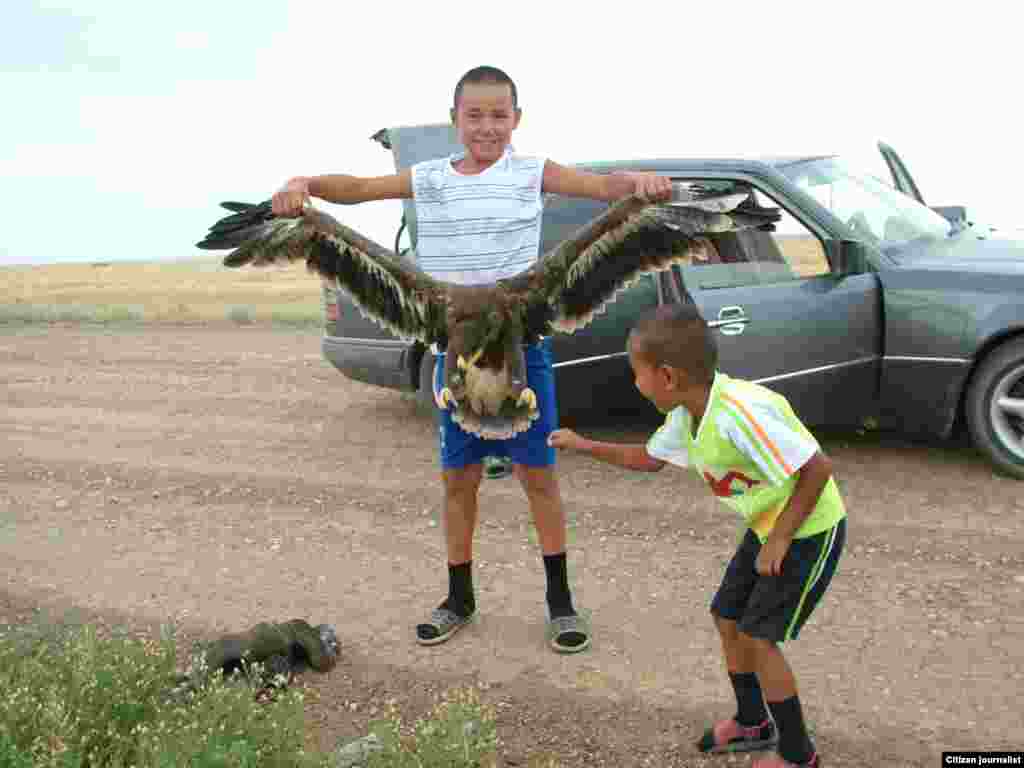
[197, 202, 445, 344]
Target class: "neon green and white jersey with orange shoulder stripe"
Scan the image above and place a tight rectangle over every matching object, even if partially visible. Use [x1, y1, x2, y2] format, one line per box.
[647, 373, 846, 542]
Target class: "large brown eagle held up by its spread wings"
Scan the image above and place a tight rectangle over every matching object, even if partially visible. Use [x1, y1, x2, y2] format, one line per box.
[197, 182, 779, 439]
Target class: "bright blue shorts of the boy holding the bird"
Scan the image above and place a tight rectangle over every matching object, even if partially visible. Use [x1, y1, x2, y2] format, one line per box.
[434, 339, 558, 469]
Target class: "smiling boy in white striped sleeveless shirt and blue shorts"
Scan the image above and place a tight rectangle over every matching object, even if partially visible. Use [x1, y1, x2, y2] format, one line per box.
[273, 67, 672, 652]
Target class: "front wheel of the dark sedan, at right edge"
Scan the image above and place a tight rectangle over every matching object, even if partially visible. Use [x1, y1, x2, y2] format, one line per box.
[966, 339, 1024, 479]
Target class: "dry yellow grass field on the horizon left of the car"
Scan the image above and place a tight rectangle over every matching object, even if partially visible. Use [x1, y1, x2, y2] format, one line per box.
[0, 259, 323, 326]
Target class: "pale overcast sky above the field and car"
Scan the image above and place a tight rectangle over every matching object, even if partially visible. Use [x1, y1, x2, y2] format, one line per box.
[0, 0, 1024, 264]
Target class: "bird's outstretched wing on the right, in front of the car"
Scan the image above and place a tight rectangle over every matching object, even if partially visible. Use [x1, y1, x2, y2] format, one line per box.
[507, 186, 779, 335]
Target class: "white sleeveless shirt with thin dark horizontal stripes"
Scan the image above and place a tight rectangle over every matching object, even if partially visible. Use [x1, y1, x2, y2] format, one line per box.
[412, 147, 545, 286]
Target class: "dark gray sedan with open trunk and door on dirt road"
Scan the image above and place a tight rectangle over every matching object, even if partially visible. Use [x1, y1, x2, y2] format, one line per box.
[323, 125, 1024, 478]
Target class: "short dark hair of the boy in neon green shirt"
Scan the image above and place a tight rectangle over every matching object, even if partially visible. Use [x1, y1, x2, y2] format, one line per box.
[630, 303, 718, 386]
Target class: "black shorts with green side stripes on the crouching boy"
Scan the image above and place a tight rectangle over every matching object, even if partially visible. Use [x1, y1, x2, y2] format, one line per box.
[711, 517, 846, 642]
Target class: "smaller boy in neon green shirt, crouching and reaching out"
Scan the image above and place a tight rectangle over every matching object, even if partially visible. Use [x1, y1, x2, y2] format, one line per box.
[549, 304, 846, 768]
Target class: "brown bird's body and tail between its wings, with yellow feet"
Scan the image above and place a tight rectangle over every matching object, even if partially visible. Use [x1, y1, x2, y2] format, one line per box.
[438, 288, 539, 439]
